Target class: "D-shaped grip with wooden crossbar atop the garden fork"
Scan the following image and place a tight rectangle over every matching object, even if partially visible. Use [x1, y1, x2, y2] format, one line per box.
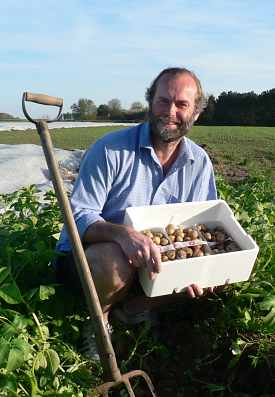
[22, 92, 63, 124]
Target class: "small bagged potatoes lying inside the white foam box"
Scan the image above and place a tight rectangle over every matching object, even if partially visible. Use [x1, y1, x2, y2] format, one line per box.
[142, 224, 240, 262]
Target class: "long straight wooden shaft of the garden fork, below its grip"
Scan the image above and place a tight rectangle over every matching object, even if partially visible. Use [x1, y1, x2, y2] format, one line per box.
[36, 120, 121, 381]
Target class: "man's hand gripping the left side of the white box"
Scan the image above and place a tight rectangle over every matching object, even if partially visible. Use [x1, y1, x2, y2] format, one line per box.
[117, 226, 161, 280]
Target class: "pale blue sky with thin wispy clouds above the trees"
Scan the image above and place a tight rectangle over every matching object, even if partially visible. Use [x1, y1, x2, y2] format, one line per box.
[0, 0, 275, 116]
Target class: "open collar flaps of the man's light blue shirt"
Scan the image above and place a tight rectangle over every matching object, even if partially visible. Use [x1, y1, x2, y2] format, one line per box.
[139, 122, 195, 161]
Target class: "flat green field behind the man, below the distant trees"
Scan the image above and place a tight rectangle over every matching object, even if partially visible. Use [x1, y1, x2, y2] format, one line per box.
[0, 126, 275, 180]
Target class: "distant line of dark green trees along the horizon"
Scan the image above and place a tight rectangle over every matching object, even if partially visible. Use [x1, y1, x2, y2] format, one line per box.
[63, 88, 275, 126]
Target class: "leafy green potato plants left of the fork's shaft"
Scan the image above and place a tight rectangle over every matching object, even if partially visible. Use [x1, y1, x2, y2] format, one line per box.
[0, 186, 100, 397]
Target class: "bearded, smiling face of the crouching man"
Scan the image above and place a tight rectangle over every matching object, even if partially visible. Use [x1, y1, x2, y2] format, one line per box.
[149, 74, 199, 142]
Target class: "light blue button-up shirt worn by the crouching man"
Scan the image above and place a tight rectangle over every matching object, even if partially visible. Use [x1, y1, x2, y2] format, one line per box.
[57, 123, 217, 251]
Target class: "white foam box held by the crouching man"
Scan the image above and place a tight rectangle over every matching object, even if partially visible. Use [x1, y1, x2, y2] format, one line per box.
[124, 200, 259, 297]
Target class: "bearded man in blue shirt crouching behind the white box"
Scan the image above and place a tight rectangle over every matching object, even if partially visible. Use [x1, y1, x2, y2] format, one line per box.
[56, 68, 217, 358]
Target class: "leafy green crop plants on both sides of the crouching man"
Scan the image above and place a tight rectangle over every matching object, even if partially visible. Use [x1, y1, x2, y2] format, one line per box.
[0, 177, 275, 397]
